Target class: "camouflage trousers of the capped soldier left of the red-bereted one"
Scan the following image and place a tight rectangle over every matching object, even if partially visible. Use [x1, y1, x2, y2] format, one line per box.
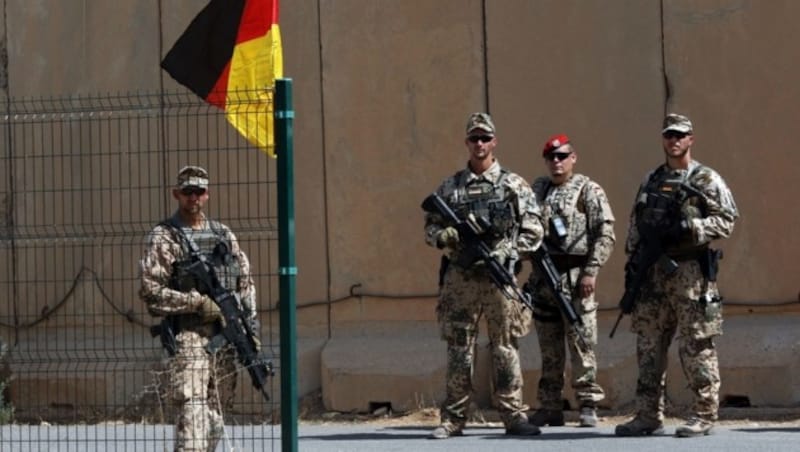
[436, 266, 531, 428]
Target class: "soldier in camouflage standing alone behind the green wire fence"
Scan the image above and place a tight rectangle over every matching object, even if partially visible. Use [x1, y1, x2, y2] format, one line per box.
[140, 166, 256, 451]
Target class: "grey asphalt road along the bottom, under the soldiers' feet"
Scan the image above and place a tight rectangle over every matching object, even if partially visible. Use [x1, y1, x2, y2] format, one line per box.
[0, 422, 800, 452]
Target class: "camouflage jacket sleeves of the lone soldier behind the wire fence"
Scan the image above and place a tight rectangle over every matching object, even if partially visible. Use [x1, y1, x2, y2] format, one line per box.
[139, 214, 256, 317]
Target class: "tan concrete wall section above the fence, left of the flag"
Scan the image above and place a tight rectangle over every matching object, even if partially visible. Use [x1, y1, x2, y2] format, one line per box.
[5, 0, 160, 97]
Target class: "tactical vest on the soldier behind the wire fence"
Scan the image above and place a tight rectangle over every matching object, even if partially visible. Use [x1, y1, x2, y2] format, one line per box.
[162, 217, 242, 291]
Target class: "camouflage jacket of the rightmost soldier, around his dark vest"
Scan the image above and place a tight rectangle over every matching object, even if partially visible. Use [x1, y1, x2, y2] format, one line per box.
[625, 160, 739, 254]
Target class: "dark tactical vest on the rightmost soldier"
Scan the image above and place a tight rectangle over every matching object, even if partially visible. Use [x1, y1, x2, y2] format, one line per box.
[636, 165, 708, 255]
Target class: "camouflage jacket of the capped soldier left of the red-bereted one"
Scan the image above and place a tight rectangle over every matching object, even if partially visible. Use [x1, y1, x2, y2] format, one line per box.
[425, 160, 543, 266]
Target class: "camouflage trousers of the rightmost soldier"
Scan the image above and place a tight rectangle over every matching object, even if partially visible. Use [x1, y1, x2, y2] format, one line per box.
[631, 260, 722, 421]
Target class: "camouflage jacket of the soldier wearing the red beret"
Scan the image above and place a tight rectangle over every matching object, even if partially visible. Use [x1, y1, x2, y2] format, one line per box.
[533, 174, 616, 276]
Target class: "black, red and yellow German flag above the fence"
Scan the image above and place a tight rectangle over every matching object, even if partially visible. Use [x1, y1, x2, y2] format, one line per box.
[161, 0, 283, 157]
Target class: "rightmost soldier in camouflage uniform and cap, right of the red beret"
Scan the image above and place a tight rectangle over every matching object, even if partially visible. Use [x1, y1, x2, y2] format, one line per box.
[615, 114, 739, 437]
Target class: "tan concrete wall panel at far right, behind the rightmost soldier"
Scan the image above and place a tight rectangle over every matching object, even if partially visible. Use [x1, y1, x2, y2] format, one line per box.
[664, 0, 800, 303]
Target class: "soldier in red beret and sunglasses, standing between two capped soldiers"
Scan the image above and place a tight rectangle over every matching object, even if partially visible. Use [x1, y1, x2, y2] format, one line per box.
[528, 135, 615, 427]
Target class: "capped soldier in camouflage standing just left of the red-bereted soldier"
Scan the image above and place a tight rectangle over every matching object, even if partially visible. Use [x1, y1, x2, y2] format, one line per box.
[425, 113, 542, 439]
